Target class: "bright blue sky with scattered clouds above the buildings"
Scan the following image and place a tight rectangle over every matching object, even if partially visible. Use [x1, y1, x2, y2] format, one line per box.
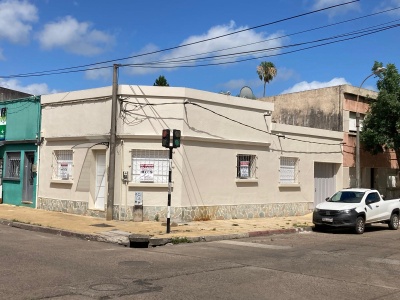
[0, 0, 400, 97]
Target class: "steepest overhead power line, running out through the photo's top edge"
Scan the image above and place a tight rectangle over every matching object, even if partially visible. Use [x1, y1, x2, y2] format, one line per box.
[0, 0, 360, 78]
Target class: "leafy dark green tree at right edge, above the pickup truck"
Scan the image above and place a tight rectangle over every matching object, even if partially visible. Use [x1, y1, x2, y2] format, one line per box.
[360, 62, 400, 166]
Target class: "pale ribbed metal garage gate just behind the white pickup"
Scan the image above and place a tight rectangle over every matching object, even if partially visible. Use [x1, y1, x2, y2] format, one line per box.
[314, 162, 336, 206]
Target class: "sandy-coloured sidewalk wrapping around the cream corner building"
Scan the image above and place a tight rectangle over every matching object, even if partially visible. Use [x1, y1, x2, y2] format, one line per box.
[0, 204, 312, 247]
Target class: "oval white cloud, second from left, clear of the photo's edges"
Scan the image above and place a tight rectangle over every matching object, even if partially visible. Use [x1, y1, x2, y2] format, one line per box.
[38, 16, 114, 56]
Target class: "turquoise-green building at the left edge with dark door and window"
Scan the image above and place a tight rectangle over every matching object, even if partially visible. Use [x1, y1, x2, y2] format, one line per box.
[0, 96, 40, 207]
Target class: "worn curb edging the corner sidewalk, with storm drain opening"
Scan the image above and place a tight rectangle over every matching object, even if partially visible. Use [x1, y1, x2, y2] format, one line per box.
[0, 219, 312, 248]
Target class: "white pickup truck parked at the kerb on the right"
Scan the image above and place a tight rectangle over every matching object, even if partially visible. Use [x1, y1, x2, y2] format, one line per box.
[313, 188, 400, 234]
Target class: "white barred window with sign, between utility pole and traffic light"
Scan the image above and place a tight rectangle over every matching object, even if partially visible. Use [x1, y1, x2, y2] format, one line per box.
[132, 149, 169, 183]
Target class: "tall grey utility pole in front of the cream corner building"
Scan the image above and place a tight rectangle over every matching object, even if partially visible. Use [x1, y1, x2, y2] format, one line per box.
[106, 64, 120, 221]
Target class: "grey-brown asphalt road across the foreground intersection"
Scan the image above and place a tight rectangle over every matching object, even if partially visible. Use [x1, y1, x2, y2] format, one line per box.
[0, 225, 400, 300]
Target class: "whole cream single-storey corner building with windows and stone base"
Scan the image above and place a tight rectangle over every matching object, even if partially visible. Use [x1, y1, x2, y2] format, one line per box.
[37, 85, 343, 221]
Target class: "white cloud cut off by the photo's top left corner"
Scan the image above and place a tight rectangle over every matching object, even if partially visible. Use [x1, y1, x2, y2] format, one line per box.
[0, 0, 38, 44]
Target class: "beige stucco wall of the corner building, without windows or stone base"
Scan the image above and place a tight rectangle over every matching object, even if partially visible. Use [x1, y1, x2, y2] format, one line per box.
[38, 85, 343, 220]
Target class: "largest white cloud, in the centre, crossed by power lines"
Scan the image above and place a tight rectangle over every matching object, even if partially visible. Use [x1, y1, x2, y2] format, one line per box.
[126, 21, 288, 74]
